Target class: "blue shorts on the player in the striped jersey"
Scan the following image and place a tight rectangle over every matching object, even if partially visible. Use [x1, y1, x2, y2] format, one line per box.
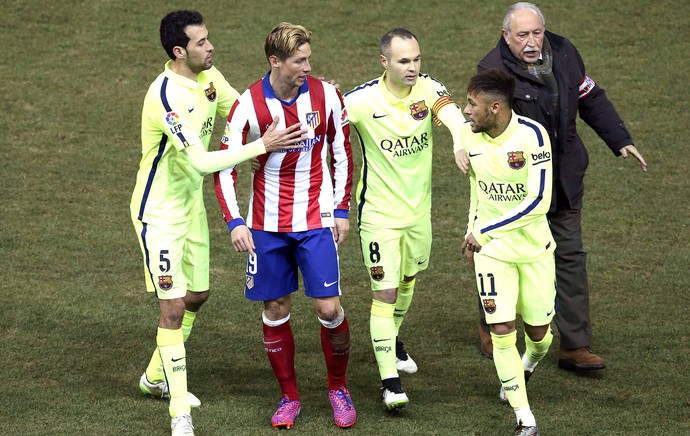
[244, 228, 341, 301]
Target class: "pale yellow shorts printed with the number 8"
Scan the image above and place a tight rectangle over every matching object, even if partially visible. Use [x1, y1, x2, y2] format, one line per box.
[359, 216, 431, 291]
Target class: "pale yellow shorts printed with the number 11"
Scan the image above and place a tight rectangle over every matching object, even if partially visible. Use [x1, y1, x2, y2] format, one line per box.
[474, 252, 556, 326]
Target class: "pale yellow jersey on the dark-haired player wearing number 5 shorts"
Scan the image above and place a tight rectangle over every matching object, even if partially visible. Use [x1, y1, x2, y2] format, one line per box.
[130, 61, 239, 222]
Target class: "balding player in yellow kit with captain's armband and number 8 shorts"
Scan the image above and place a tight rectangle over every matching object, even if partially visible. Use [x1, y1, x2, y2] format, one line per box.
[345, 28, 467, 409]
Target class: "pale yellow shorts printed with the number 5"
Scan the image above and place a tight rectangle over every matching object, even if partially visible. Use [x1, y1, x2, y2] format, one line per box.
[132, 210, 209, 300]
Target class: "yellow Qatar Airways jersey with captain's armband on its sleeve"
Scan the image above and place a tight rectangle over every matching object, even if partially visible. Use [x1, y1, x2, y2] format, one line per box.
[345, 73, 455, 228]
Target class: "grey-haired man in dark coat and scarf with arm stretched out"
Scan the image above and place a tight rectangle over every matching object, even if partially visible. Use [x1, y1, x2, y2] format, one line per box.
[477, 2, 647, 371]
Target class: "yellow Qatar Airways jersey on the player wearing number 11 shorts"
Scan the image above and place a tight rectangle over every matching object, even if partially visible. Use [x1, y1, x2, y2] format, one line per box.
[460, 112, 556, 262]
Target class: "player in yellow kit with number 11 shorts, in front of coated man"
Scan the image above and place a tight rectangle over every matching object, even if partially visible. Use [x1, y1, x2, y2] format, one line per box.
[460, 69, 556, 435]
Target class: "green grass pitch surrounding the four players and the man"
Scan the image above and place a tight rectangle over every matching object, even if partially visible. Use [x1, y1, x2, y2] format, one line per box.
[0, 0, 690, 435]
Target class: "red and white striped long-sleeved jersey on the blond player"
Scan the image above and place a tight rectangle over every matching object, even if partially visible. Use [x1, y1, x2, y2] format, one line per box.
[214, 72, 353, 232]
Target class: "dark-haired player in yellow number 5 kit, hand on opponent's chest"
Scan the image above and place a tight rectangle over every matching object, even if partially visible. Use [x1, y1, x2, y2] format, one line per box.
[130, 11, 306, 435]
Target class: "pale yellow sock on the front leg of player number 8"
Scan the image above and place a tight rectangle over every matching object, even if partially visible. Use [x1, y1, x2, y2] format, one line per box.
[369, 300, 398, 380]
